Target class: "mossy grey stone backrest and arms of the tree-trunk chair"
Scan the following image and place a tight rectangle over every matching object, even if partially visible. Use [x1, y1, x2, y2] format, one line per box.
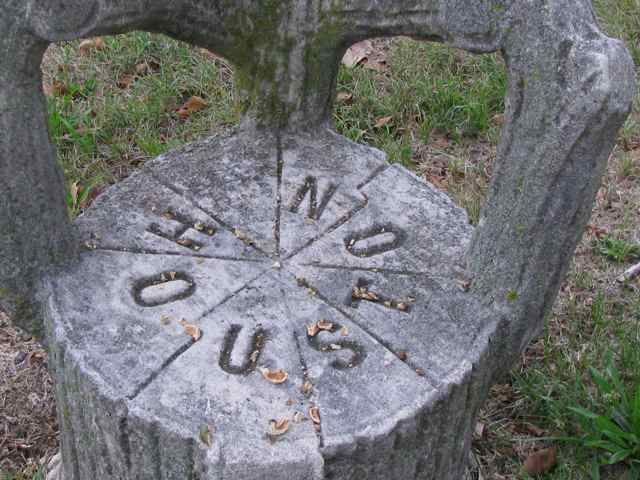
[0, 0, 634, 353]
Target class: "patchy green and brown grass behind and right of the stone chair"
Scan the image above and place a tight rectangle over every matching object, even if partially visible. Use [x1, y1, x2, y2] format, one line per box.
[0, 0, 640, 480]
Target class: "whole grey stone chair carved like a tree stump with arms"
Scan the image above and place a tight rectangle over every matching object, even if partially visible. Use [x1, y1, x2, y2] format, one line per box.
[0, 0, 635, 480]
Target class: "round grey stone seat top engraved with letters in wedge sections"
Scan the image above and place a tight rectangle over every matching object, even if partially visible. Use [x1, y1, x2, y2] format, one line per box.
[50, 126, 498, 478]
